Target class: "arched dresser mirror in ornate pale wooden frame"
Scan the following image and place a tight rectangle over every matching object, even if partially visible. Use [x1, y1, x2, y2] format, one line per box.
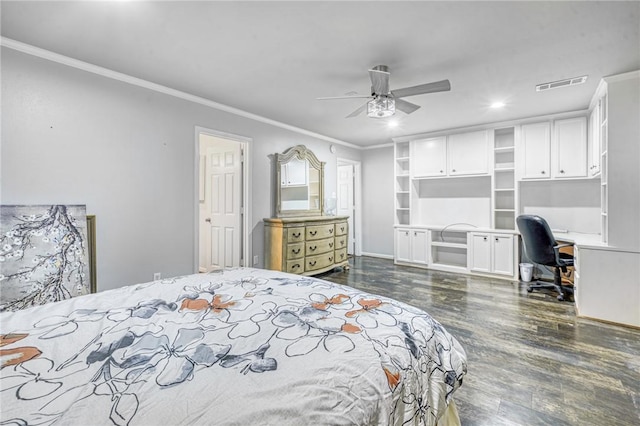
[275, 145, 324, 217]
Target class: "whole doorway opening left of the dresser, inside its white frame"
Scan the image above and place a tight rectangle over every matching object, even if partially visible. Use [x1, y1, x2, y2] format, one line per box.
[195, 128, 249, 272]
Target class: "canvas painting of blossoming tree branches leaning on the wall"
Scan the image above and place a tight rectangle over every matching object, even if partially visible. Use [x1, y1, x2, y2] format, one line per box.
[0, 205, 92, 311]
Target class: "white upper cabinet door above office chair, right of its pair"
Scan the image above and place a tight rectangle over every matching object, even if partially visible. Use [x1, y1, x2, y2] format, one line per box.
[551, 117, 587, 178]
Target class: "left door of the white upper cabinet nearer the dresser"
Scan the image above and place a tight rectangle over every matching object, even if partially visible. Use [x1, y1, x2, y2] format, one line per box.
[411, 136, 447, 178]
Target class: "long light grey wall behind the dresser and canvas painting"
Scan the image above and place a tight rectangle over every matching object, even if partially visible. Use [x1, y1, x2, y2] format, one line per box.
[0, 48, 360, 290]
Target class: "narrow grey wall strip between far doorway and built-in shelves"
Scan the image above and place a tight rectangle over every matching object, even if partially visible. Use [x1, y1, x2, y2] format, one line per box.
[362, 146, 395, 256]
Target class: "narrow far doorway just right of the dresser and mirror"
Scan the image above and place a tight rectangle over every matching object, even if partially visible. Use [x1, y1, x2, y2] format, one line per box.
[336, 158, 362, 256]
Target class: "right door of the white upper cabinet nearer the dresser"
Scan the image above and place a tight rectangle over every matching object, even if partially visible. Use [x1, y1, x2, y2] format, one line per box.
[448, 130, 489, 176]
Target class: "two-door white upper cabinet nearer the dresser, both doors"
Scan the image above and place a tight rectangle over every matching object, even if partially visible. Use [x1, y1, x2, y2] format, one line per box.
[411, 130, 490, 179]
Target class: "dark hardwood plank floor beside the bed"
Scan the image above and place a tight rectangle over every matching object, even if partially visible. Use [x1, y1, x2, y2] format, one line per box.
[319, 257, 640, 426]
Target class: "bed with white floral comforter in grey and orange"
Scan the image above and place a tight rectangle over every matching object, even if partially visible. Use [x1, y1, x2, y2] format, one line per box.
[0, 268, 466, 425]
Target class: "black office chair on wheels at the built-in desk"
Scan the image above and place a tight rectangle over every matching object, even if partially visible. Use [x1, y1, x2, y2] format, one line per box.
[516, 215, 573, 300]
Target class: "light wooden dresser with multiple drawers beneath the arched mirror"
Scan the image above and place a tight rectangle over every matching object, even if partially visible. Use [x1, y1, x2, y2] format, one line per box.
[264, 216, 349, 275]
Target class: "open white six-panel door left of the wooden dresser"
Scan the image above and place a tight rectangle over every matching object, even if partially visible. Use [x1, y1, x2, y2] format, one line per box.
[200, 134, 242, 271]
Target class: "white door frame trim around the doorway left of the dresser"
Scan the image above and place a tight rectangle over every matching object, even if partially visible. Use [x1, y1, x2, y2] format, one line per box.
[193, 126, 253, 274]
